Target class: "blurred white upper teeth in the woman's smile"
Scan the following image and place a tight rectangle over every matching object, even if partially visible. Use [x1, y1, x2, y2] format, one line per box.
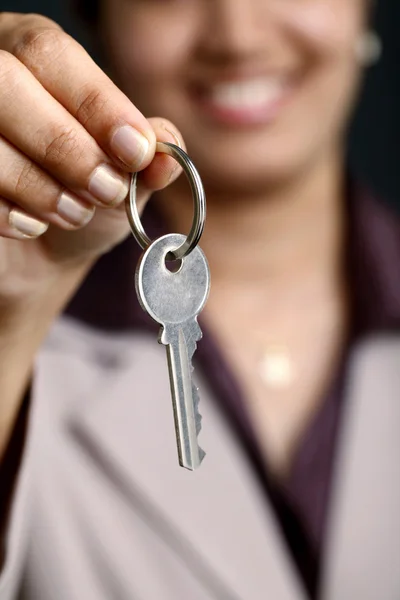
[210, 77, 286, 109]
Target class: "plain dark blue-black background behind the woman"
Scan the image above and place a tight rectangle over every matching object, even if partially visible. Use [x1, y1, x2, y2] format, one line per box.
[0, 0, 400, 209]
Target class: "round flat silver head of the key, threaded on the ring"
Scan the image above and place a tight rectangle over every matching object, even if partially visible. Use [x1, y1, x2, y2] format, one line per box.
[136, 233, 210, 328]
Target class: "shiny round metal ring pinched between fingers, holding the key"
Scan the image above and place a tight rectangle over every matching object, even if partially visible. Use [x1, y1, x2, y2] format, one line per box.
[126, 142, 206, 260]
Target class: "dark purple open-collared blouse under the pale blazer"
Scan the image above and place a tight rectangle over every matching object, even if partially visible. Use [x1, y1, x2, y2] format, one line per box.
[67, 180, 400, 599]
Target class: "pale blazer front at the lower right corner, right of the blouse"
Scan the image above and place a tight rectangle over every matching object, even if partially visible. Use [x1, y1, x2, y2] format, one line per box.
[323, 338, 400, 600]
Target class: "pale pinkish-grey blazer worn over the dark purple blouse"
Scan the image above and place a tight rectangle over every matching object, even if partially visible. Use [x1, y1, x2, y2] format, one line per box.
[0, 318, 400, 600]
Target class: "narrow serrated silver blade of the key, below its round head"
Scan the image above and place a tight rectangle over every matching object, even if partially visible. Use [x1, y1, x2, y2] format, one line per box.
[161, 328, 205, 471]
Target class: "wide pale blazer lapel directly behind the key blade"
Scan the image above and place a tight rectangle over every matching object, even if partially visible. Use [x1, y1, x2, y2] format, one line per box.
[39, 320, 305, 600]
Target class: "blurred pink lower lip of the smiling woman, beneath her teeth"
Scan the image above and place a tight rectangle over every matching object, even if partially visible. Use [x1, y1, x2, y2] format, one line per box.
[195, 88, 292, 126]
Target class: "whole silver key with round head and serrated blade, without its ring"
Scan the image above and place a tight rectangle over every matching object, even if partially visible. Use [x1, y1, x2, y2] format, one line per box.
[136, 233, 210, 471]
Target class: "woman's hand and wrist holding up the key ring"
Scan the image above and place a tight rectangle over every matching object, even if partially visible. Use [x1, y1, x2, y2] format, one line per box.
[0, 13, 185, 446]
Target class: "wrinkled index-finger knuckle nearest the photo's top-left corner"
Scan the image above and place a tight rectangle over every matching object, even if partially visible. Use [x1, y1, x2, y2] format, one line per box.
[13, 24, 71, 66]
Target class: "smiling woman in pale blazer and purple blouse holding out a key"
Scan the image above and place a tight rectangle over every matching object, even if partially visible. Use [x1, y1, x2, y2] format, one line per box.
[0, 0, 400, 600]
